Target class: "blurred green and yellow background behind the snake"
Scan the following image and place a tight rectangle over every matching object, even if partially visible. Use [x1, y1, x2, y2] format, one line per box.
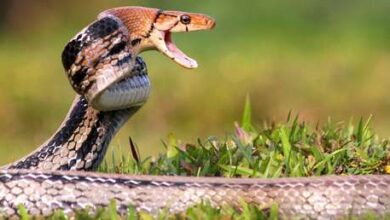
[0, 0, 390, 164]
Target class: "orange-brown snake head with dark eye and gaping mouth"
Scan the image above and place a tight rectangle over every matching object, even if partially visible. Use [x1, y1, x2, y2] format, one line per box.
[99, 7, 215, 69]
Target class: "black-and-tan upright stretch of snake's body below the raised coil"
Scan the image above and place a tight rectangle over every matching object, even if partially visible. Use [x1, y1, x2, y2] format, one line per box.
[5, 96, 140, 170]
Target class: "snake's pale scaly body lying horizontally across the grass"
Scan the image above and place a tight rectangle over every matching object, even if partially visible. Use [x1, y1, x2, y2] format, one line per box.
[0, 170, 390, 219]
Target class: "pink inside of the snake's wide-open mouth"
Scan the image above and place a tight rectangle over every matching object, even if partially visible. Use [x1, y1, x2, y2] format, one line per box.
[164, 32, 198, 69]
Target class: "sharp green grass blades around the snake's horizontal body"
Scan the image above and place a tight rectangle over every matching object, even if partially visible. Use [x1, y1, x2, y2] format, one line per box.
[19, 99, 390, 219]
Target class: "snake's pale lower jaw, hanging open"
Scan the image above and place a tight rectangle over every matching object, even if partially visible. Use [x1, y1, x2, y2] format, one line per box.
[157, 32, 198, 69]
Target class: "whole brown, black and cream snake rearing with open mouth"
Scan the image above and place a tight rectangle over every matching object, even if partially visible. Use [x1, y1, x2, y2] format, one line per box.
[0, 6, 390, 219]
